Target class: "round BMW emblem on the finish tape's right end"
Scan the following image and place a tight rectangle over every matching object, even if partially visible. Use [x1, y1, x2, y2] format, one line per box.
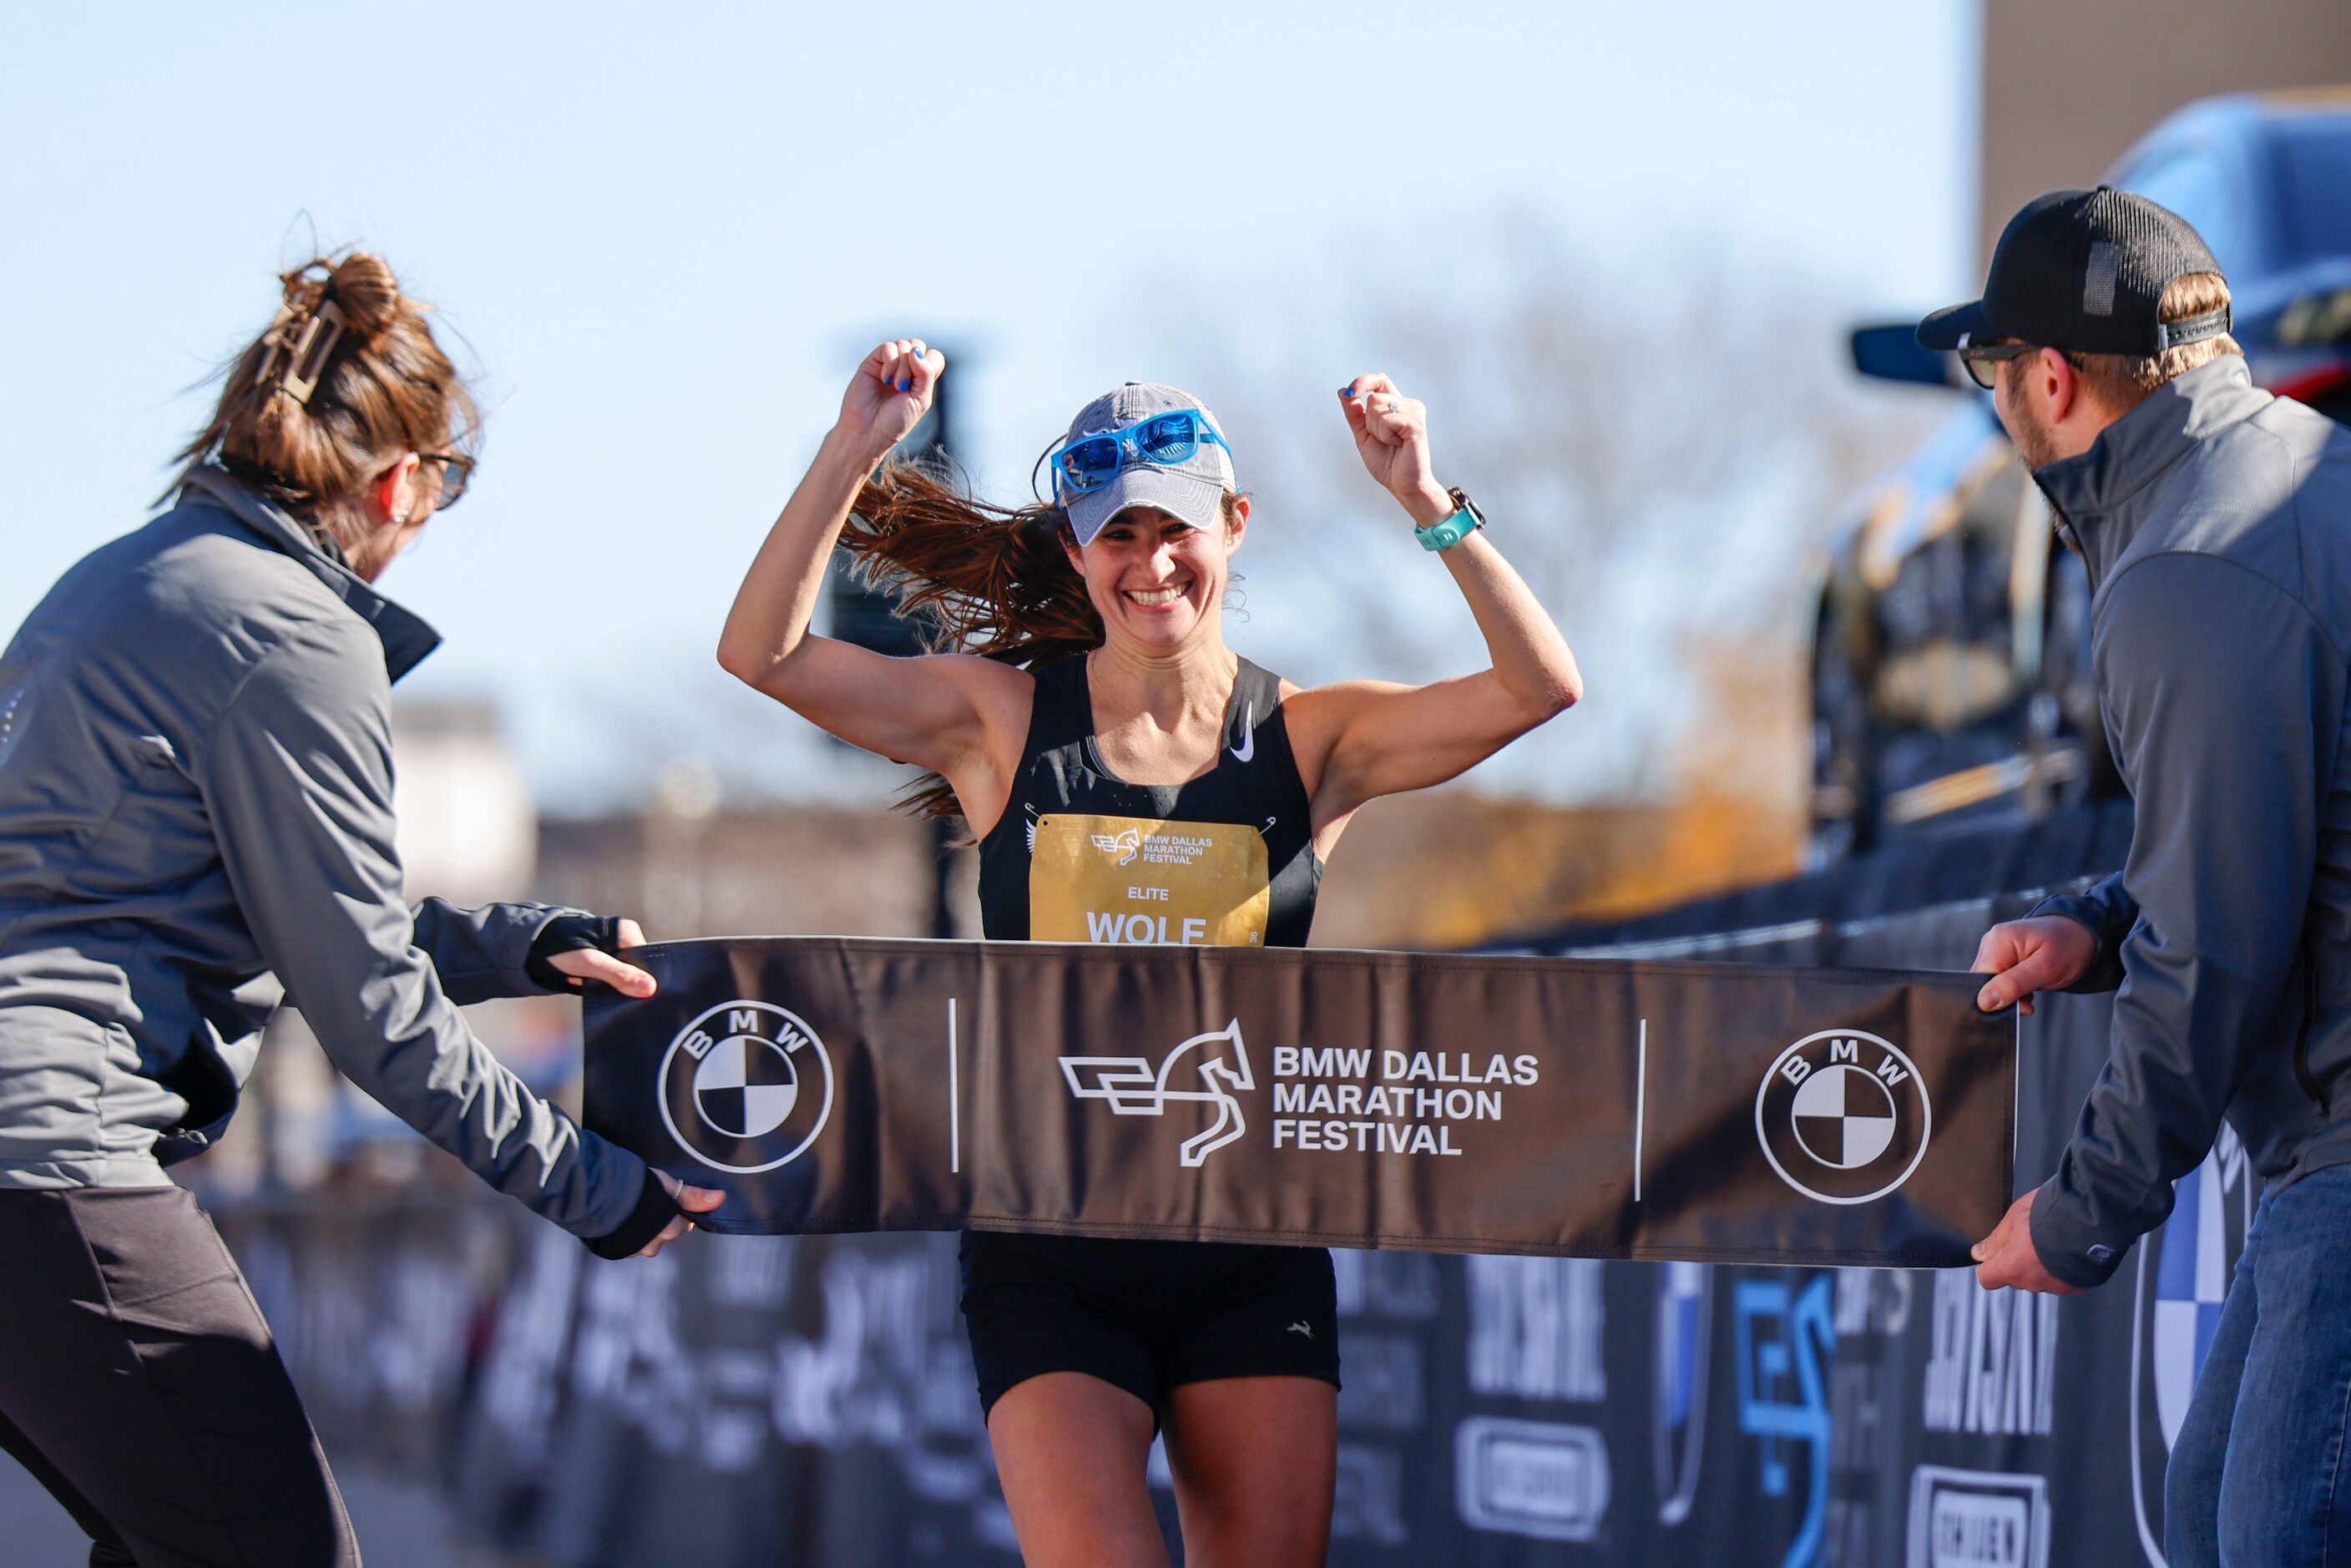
[1757, 1029, 1933, 1204]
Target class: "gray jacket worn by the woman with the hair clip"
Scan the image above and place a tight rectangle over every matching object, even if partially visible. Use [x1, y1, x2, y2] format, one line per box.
[0, 468, 663, 1251]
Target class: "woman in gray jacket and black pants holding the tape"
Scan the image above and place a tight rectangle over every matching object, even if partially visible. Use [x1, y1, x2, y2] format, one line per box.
[0, 254, 720, 1568]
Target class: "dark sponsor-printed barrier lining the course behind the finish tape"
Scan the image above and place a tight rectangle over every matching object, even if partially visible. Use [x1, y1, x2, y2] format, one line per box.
[190, 869, 2219, 1568]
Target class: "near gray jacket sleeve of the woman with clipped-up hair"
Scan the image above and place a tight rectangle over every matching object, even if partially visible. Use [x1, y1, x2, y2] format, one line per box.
[193, 620, 649, 1239]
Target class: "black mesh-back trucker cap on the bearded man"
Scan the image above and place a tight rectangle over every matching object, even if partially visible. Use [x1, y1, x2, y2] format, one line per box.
[1919, 185, 2229, 357]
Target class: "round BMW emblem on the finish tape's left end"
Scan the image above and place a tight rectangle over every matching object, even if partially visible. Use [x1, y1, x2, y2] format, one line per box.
[660, 1001, 832, 1176]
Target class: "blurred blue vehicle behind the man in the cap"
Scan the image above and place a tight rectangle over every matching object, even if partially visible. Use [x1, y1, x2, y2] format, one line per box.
[1813, 89, 2351, 862]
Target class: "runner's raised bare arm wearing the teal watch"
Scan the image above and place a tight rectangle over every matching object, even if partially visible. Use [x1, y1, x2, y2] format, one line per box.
[1288, 376, 1585, 830]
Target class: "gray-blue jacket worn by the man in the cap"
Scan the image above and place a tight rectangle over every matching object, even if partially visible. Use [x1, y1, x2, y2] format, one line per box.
[2031, 355, 2351, 1286]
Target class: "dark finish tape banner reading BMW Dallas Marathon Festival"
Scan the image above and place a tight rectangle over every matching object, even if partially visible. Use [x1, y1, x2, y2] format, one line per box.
[585, 938, 2017, 1267]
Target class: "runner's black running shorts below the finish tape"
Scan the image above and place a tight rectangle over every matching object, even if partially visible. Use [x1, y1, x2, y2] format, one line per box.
[962, 1232, 1337, 1420]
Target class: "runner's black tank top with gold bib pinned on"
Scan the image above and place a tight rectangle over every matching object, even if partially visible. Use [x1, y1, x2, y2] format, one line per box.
[980, 658, 1322, 948]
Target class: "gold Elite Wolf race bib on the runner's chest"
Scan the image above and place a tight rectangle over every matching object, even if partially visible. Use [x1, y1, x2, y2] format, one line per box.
[1029, 813, 1274, 948]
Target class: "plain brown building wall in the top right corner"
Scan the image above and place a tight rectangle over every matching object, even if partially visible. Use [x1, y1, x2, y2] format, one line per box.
[1977, 0, 2351, 261]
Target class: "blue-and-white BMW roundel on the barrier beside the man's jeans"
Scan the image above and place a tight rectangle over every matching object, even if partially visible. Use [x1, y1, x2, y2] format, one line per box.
[2130, 1121, 2259, 1568]
